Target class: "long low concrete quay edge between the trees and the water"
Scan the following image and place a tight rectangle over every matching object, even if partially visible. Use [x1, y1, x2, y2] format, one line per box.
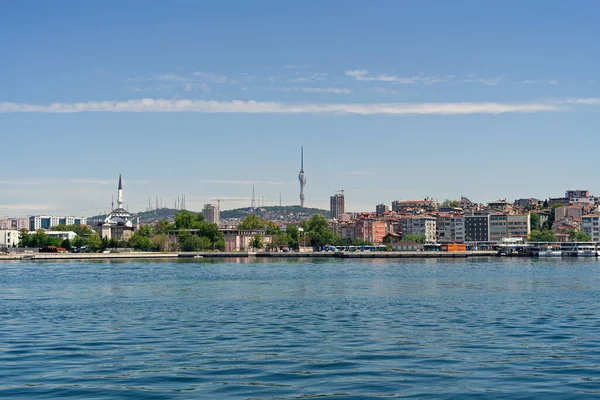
[0, 251, 497, 261]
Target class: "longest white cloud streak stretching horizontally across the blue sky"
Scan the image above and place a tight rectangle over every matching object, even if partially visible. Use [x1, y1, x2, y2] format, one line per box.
[0, 98, 572, 115]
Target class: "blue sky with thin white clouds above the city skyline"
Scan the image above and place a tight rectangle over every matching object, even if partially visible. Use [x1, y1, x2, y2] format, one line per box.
[0, 0, 600, 217]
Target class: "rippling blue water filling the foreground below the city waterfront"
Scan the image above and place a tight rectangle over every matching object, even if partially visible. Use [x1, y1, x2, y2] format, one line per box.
[0, 258, 600, 399]
